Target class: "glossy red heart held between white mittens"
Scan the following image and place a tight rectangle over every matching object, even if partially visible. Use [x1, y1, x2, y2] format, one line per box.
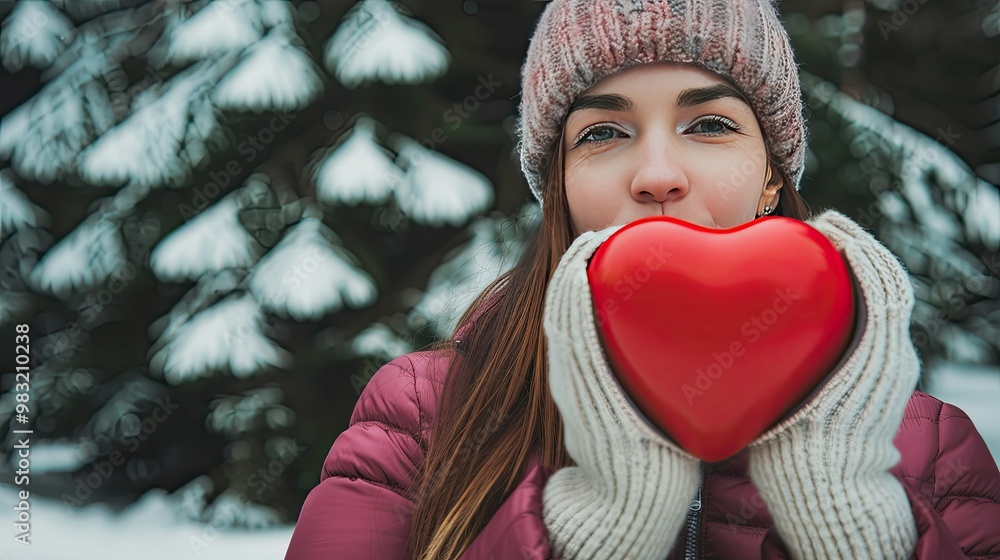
[587, 216, 854, 462]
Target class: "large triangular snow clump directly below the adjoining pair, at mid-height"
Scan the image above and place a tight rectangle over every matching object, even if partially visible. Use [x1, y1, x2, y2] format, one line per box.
[249, 217, 377, 321]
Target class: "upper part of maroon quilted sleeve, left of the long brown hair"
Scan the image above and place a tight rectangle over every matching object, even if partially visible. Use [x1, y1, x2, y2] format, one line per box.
[285, 355, 433, 560]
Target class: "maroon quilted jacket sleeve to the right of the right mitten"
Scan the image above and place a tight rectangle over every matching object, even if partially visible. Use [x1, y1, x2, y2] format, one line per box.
[894, 392, 1000, 560]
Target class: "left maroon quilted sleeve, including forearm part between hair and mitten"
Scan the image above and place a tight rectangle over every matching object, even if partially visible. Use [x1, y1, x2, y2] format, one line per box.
[285, 352, 564, 560]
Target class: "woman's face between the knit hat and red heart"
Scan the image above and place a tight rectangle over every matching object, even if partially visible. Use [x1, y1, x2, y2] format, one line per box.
[563, 63, 781, 235]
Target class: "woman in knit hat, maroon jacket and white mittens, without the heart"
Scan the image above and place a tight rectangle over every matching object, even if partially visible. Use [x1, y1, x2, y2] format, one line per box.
[286, 0, 1000, 560]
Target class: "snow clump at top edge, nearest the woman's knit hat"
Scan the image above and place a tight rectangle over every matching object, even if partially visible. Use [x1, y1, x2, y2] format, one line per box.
[324, 0, 451, 88]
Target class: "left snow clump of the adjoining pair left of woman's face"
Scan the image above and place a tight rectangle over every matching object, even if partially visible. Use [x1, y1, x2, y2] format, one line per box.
[313, 117, 402, 206]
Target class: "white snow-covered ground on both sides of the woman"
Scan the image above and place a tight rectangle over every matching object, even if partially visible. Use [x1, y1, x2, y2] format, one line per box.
[0, 366, 1000, 560]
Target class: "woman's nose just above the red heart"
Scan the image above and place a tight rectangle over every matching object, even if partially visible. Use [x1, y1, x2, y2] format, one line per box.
[631, 138, 689, 202]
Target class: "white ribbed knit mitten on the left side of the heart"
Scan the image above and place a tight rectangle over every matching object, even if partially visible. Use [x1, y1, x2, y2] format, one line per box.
[542, 226, 699, 560]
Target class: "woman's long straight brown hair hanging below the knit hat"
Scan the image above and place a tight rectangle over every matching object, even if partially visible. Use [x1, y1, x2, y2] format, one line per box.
[410, 134, 810, 560]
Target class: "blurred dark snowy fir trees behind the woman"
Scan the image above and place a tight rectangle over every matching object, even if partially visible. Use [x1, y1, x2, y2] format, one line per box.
[0, 0, 1000, 527]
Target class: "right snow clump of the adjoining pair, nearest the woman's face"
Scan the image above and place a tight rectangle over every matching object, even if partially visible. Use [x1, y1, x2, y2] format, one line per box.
[390, 134, 493, 227]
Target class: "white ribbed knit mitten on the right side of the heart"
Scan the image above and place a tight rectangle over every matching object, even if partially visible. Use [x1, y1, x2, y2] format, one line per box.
[750, 210, 920, 559]
